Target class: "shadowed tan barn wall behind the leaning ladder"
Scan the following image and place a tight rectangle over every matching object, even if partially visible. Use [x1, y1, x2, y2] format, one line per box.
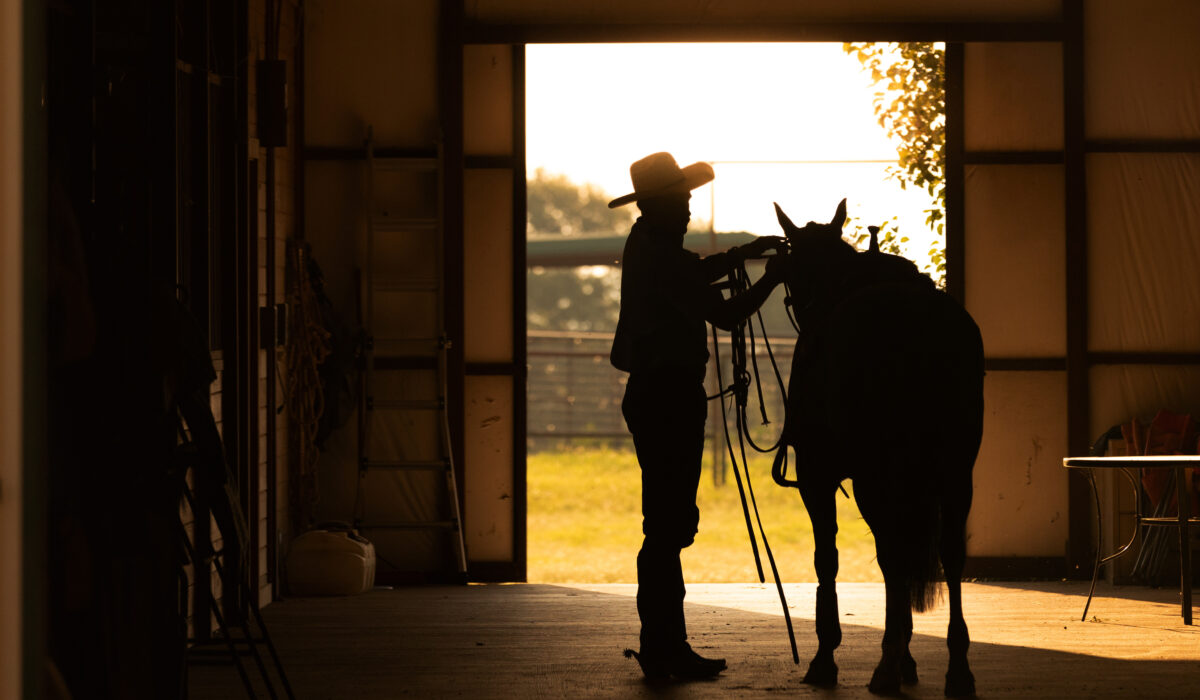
[304, 0, 462, 581]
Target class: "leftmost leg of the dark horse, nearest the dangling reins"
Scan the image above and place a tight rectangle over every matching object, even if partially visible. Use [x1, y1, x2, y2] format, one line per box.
[800, 486, 841, 686]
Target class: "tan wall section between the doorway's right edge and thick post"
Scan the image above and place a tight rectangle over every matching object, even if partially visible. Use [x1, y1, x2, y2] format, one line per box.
[962, 42, 1069, 558]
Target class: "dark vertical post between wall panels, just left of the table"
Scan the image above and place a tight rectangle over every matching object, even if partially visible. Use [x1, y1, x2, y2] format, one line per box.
[1062, 0, 1091, 576]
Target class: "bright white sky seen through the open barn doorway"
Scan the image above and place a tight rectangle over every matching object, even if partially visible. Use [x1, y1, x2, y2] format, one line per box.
[526, 43, 931, 262]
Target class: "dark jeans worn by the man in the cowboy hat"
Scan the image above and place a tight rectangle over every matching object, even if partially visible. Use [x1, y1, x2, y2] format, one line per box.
[622, 369, 708, 652]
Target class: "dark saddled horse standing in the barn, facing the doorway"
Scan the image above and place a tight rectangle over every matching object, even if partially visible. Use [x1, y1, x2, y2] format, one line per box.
[773, 199, 984, 696]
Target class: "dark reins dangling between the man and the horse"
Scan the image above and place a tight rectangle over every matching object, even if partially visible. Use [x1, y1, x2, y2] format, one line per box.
[713, 254, 800, 665]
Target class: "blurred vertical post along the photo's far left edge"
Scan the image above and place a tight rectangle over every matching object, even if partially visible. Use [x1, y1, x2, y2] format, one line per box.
[7, 0, 47, 698]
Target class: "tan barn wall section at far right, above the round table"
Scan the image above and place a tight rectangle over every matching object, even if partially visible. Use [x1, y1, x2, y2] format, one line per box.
[1084, 0, 1200, 576]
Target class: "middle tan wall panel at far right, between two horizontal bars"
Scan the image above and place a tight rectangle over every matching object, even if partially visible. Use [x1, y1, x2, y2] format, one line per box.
[1087, 154, 1200, 352]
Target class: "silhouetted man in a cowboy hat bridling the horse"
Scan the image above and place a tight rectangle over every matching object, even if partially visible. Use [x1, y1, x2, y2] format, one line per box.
[608, 152, 782, 680]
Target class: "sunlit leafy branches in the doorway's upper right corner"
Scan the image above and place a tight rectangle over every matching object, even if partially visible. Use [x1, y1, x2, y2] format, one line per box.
[842, 42, 946, 283]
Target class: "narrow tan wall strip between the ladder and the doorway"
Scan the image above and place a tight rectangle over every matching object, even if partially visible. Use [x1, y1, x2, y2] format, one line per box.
[462, 44, 524, 569]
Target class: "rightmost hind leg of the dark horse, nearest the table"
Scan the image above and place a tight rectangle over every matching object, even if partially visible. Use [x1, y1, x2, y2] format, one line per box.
[941, 474, 976, 698]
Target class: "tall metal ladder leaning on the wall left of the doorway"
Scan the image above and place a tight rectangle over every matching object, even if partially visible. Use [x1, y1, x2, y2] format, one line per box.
[354, 127, 467, 582]
